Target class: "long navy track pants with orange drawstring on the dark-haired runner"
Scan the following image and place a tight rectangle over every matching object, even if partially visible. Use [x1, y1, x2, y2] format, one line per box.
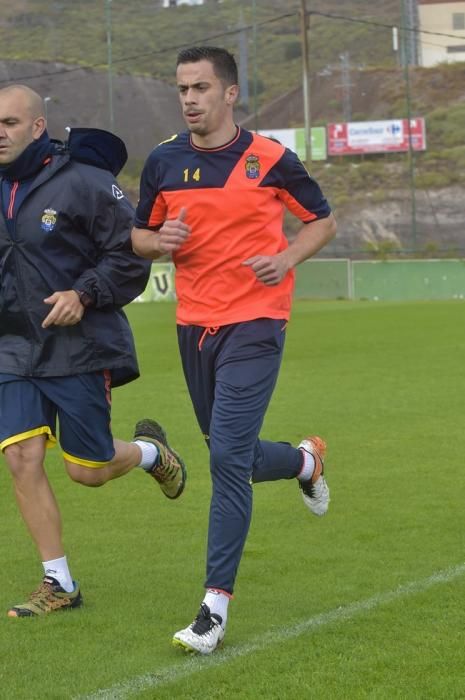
[178, 318, 302, 593]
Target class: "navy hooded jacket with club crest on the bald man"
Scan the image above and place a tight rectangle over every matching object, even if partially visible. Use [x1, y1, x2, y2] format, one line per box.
[0, 129, 150, 386]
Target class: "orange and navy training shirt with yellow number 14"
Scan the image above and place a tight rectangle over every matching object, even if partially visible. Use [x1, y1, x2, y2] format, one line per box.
[135, 128, 331, 326]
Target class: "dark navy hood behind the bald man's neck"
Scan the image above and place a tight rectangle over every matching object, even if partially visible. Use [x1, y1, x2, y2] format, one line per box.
[54, 128, 128, 177]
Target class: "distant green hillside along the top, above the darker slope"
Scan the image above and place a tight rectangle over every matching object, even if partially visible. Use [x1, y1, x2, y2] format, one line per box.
[0, 0, 399, 106]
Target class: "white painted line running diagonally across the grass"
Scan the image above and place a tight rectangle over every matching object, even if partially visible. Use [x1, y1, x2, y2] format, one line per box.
[75, 563, 465, 700]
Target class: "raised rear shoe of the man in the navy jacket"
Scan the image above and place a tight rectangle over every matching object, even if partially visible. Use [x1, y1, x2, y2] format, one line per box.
[134, 418, 187, 498]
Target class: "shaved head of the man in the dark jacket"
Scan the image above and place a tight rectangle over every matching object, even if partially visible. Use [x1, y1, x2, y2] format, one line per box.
[0, 85, 46, 165]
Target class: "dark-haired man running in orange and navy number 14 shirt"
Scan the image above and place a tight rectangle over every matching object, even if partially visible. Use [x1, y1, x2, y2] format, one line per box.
[132, 46, 336, 654]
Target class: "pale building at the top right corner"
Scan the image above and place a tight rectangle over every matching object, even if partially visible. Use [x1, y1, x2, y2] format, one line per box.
[418, 0, 465, 67]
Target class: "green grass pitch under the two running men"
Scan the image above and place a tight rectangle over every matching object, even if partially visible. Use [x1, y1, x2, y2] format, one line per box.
[0, 302, 465, 700]
